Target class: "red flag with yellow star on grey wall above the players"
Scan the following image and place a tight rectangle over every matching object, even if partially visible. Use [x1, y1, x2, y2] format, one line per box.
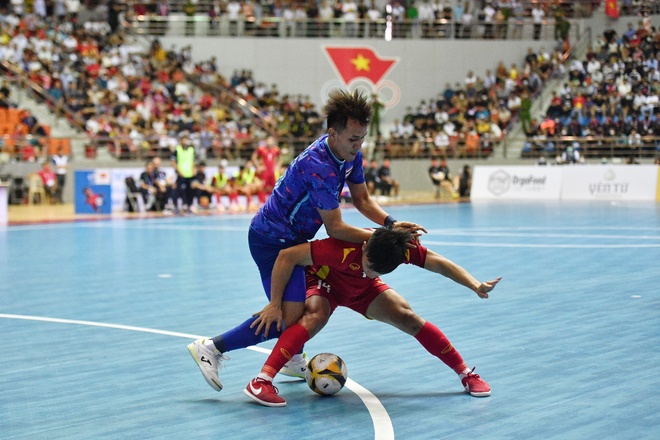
[325, 47, 398, 84]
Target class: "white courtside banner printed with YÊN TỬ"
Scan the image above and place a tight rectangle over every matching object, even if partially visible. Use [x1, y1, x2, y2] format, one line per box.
[561, 165, 658, 201]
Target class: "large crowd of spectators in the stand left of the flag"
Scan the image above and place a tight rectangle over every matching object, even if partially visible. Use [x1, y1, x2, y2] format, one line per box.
[0, 7, 320, 159]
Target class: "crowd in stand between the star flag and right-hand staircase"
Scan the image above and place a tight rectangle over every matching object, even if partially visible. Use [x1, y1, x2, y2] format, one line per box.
[381, 42, 566, 157]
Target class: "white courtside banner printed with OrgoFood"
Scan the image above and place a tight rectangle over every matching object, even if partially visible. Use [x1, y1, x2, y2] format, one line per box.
[470, 166, 562, 200]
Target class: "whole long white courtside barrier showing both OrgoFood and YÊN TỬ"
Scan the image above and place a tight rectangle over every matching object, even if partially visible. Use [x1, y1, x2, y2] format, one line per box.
[471, 165, 660, 201]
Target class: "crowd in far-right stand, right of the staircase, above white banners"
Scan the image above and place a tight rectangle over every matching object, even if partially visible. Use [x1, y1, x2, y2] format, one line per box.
[523, 17, 660, 157]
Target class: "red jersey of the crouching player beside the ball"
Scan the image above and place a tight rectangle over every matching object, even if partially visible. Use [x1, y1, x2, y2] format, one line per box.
[310, 238, 426, 297]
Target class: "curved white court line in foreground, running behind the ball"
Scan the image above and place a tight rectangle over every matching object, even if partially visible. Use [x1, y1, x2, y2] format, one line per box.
[0, 313, 394, 440]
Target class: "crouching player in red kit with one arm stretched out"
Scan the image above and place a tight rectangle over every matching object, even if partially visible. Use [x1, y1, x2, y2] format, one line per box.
[244, 228, 502, 406]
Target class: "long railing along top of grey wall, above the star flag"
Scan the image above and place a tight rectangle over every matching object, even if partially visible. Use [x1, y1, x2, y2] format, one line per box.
[123, 13, 581, 41]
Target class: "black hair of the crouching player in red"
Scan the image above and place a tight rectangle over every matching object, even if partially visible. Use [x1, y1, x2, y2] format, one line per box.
[365, 228, 412, 275]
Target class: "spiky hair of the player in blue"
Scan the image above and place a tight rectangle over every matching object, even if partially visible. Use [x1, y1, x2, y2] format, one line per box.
[323, 89, 373, 131]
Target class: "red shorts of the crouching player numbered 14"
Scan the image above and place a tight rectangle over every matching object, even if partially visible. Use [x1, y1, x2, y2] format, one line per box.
[306, 273, 390, 317]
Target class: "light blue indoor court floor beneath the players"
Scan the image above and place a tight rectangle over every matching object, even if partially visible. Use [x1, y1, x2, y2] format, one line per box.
[0, 202, 660, 440]
